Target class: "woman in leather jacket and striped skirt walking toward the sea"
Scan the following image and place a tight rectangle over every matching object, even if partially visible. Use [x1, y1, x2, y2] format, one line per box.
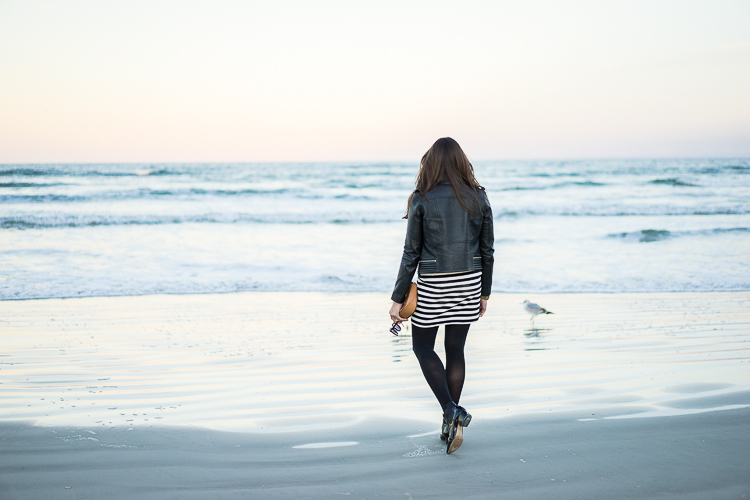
[390, 137, 494, 454]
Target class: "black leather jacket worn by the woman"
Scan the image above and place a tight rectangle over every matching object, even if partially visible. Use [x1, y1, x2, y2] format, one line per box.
[391, 180, 495, 303]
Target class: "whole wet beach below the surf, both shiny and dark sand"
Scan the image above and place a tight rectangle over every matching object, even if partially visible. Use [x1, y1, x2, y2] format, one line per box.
[0, 292, 750, 499]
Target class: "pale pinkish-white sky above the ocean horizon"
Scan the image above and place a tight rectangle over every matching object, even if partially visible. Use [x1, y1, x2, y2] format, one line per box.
[0, 0, 750, 163]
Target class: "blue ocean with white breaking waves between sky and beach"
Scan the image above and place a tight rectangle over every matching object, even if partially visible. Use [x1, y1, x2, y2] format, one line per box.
[0, 159, 750, 299]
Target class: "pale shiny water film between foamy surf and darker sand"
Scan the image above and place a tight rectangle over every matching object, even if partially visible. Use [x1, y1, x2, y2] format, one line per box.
[0, 292, 750, 432]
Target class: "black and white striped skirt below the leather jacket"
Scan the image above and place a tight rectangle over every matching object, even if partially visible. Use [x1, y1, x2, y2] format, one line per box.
[411, 271, 482, 328]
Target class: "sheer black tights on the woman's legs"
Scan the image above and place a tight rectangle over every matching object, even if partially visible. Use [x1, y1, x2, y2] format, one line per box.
[411, 324, 471, 410]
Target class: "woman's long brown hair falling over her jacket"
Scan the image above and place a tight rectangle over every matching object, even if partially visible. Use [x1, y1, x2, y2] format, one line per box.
[404, 137, 484, 219]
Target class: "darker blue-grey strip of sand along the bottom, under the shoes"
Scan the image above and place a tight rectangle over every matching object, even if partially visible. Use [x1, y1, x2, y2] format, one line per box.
[0, 409, 750, 500]
